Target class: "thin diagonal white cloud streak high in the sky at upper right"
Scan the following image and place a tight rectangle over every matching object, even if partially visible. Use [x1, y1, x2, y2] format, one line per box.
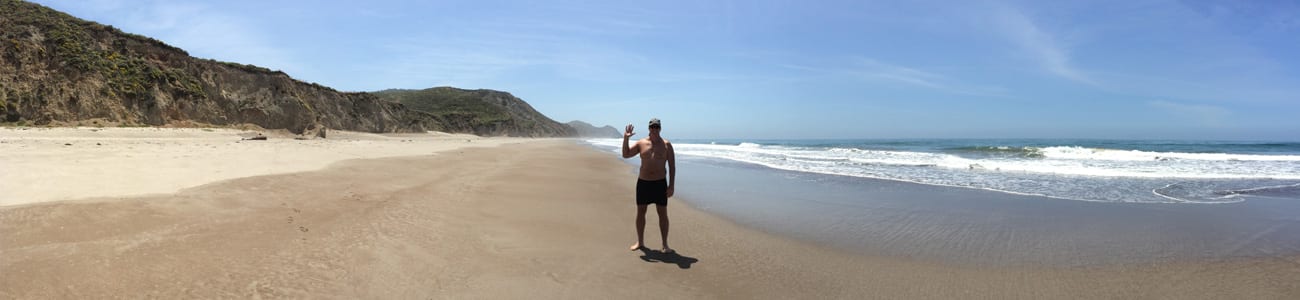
[995, 5, 1096, 84]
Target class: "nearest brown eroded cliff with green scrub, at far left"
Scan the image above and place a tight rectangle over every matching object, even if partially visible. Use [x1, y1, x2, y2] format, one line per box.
[0, 0, 431, 132]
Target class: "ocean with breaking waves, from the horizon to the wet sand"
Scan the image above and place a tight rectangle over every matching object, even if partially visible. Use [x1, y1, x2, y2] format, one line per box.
[586, 139, 1300, 204]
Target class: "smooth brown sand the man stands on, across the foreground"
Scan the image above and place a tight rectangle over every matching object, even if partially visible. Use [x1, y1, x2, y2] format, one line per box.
[0, 129, 1300, 299]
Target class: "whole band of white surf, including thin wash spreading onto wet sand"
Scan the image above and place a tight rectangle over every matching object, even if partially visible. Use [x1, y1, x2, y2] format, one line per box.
[588, 139, 1300, 203]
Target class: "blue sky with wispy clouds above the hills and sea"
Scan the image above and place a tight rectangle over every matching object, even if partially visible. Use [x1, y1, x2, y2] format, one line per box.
[36, 0, 1300, 140]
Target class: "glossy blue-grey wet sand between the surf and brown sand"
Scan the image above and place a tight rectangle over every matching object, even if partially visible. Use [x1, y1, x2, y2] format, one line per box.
[677, 158, 1300, 266]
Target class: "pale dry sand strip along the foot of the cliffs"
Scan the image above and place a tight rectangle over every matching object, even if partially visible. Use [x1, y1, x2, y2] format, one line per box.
[0, 127, 517, 205]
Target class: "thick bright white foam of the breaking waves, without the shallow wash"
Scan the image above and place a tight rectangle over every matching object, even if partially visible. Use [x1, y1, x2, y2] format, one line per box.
[589, 140, 1300, 179]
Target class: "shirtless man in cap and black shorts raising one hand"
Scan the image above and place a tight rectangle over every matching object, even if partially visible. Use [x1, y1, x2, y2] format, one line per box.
[623, 118, 677, 253]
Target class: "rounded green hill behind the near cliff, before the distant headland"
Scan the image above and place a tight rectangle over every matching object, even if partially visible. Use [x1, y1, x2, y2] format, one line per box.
[373, 87, 576, 136]
